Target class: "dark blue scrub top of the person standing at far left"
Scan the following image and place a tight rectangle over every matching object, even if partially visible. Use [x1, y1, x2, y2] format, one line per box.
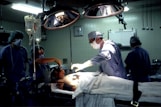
[0, 44, 28, 83]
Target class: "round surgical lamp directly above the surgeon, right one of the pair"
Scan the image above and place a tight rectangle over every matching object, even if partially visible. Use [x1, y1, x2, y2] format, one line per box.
[83, 0, 124, 18]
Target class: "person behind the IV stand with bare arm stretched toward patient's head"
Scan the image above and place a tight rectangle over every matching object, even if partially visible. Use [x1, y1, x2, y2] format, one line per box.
[29, 46, 62, 84]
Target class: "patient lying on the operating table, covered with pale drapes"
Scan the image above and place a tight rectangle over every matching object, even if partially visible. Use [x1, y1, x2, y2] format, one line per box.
[51, 67, 161, 105]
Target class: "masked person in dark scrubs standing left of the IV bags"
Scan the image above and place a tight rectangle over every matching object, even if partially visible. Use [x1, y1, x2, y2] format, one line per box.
[0, 30, 28, 104]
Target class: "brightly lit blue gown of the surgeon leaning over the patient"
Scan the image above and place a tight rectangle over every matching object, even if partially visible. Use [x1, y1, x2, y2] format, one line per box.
[91, 40, 126, 78]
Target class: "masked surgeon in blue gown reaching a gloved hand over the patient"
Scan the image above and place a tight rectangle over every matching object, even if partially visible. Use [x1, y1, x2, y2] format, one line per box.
[71, 31, 127, 78]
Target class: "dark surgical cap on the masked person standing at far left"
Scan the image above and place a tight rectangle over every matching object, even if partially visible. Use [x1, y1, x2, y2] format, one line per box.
[8, 30, 24, 43]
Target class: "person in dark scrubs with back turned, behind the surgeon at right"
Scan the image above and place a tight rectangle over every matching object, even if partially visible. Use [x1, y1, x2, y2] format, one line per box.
[125, 36, 151, 82]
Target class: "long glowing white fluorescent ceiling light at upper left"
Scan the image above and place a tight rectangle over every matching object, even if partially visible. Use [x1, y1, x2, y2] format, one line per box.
[11, 3, 43, 14]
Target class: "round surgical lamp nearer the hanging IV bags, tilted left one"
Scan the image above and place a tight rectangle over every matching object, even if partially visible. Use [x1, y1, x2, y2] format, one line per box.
[43, 6, 80, 30]
